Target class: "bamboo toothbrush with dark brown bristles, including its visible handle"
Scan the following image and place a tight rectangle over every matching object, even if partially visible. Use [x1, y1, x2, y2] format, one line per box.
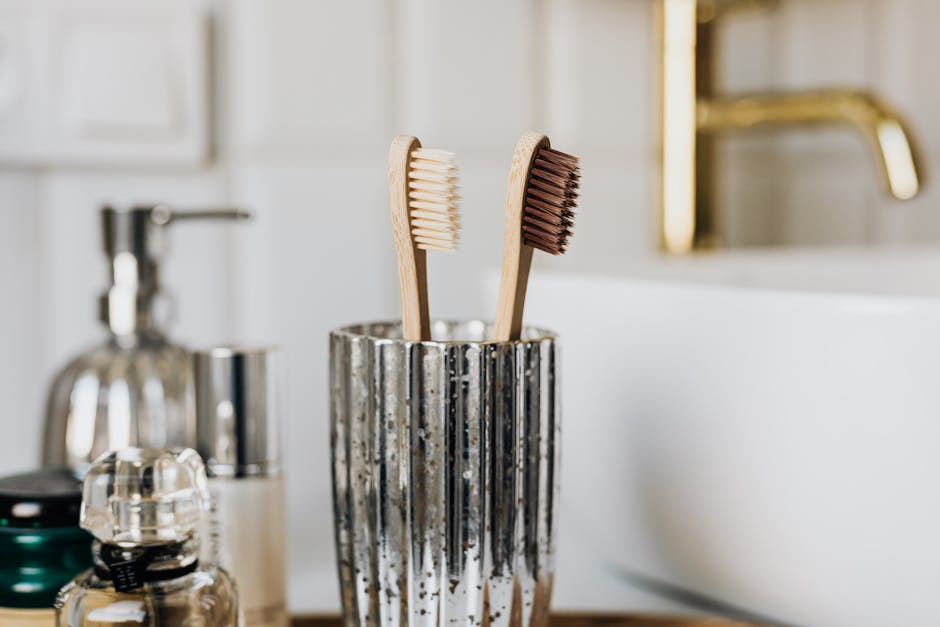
[494, 132, 581, 342]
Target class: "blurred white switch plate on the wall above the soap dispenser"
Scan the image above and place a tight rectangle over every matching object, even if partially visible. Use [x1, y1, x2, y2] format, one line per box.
[0, 0, 209, 169]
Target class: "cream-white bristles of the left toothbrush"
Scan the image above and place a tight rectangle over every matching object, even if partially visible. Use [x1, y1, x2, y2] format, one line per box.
[408, 148, 460, 251]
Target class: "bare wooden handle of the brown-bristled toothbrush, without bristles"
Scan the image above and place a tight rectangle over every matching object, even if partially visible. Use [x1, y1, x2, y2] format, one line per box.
[493, 132, 550, 342]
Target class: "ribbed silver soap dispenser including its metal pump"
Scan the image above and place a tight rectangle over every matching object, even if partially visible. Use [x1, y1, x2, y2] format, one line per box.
[42, 205, 250, 472]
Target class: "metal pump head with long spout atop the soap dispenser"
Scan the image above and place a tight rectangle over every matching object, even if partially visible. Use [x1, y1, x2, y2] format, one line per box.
[98, 205, 251, 337]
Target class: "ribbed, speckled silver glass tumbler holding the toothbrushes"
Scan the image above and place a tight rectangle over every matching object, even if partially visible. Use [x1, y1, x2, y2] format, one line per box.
[330, 322, 560, 627]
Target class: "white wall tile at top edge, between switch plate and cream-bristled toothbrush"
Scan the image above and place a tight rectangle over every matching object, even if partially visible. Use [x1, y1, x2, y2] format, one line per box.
[227, 0, 392, 158]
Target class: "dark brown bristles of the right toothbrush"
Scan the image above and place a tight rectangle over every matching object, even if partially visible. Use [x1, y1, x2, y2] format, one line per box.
[522, 148, 581, 255]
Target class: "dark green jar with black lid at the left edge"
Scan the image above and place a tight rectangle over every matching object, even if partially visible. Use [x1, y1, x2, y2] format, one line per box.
[0, 470, 92, 627]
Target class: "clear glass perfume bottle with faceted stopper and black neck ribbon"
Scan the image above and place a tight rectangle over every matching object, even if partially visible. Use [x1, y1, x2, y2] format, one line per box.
[56, 448, 238, 627]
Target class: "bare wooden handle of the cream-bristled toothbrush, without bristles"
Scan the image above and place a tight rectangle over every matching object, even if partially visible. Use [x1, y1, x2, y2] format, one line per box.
[388, 135, 431, 341]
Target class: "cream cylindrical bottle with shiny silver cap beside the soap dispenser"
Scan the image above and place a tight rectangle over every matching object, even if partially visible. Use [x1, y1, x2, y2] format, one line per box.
[193, 348, 289, 627]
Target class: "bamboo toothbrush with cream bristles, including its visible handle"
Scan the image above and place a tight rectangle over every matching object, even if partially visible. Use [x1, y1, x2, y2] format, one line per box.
[388, 135, 460, 341]
